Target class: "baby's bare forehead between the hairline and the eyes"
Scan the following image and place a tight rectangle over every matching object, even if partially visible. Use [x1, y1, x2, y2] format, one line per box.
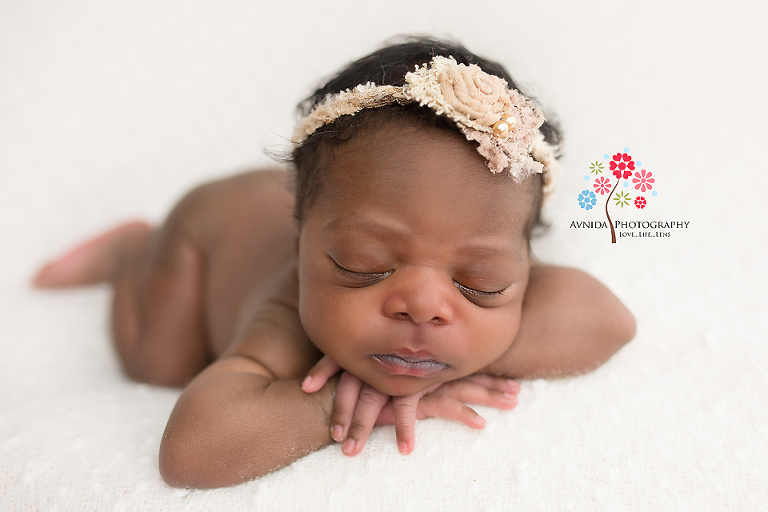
[300, 117, 540, 238]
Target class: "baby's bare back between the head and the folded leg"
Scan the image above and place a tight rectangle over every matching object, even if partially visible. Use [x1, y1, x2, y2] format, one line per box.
[177, 169, 297, 357]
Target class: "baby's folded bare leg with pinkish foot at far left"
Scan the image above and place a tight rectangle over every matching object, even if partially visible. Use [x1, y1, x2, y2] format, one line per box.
[34, 214, 211, 386]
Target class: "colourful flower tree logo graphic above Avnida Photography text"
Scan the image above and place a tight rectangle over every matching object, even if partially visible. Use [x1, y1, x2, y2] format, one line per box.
[578, 148, 658, 244]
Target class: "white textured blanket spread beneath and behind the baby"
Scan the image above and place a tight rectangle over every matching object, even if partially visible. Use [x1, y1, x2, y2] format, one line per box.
[0, 0, 768, 511]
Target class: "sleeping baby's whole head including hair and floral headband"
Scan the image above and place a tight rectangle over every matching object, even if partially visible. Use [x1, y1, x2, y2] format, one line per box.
[294, 39, 558, 395]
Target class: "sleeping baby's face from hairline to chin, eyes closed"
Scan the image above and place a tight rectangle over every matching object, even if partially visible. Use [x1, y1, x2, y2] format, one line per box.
[299, 121, 533, 396]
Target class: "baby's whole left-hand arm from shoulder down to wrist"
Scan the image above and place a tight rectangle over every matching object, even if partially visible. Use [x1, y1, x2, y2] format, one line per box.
[160, 268, 337, 488]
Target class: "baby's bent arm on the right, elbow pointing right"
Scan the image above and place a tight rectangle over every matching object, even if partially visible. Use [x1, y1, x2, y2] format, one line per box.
[479, 265, 635, 379]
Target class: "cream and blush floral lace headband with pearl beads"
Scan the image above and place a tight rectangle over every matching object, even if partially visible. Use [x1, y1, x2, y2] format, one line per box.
[293, 56, 557, 196]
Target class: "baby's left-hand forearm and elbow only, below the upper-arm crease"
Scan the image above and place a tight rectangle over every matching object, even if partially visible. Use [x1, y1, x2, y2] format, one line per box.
[159, 355, 337, 488]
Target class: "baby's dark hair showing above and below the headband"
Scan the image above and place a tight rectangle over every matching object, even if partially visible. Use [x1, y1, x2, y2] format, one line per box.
[290, 36, 562, 236]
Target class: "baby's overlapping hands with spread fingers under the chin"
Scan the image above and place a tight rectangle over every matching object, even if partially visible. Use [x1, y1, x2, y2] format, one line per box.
[302, 356, 520, 456]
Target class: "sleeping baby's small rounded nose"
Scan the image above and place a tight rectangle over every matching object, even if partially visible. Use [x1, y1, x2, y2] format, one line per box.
[384, 269, 456, 325]
